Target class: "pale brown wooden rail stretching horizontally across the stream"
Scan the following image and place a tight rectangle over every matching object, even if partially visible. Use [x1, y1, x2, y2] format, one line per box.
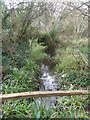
[0, 90, 90, 101]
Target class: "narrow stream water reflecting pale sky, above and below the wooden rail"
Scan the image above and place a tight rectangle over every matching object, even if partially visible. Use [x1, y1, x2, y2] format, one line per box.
[36, 64, 57, 107]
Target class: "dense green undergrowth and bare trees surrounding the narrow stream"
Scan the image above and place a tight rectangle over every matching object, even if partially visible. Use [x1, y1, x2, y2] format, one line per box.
[0, 1, 90, 119]
